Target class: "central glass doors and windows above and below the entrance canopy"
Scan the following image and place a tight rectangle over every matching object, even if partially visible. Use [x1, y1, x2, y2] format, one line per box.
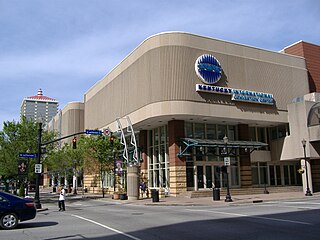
[185, 122, 240, 190]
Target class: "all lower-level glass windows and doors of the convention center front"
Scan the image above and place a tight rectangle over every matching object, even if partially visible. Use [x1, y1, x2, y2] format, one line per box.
[148, 122, 302, 192]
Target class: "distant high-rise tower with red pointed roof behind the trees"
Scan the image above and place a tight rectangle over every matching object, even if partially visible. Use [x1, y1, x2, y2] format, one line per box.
[20, 88, 59, 124]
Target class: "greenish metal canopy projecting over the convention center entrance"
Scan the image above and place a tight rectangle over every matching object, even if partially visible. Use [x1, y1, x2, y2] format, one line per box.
[177, 138, 268, 157]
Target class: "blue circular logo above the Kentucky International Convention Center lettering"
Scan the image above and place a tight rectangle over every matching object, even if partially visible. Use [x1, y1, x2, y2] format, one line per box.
[195, 54, 222, 84]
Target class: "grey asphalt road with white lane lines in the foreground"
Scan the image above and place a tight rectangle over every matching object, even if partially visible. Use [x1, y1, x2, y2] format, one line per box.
[0, 199, 320, 240]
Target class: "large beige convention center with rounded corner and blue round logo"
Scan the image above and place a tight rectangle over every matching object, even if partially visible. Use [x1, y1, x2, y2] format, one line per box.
[47, 32, 320, 196]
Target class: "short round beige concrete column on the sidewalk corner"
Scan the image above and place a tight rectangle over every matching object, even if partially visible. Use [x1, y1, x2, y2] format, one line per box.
[127, 166, 139, 200]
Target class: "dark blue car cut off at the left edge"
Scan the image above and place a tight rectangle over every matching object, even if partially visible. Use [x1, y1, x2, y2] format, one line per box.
[0, 192, 37, 229]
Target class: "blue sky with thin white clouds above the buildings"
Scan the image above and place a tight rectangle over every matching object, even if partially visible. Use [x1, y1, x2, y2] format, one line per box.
[0, 0, 320, 130]
